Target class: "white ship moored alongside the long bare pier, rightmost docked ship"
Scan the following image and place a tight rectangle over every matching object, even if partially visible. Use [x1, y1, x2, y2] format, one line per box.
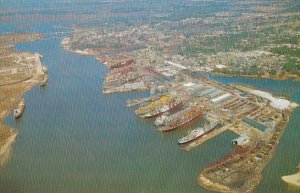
[178, 121, 219, 145]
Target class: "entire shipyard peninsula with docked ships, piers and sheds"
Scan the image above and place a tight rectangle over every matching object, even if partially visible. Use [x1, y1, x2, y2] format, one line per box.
[62, 15, 298, 193]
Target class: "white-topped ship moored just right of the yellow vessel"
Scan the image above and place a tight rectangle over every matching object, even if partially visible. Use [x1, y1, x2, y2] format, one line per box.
[141, 99, 182, 118]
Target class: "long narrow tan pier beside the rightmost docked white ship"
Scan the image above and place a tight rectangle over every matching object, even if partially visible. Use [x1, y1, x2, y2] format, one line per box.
[180, 124, 233, 151]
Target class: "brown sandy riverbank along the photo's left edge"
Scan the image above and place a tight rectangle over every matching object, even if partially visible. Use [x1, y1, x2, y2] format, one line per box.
[0, 34, 48, 169]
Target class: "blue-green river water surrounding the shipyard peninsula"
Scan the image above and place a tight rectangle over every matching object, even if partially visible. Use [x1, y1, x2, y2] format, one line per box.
[0, 35, 300, 193]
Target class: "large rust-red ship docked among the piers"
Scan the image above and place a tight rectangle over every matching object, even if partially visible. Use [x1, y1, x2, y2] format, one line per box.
[158, 106, 203, 132]
